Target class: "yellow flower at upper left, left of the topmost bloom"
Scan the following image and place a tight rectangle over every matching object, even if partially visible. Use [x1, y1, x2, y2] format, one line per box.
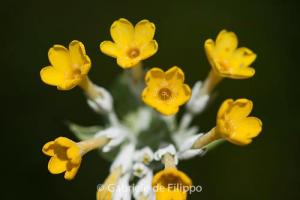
[40, 40, 91, 90]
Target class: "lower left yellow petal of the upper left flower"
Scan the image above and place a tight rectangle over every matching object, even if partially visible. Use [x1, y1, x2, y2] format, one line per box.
[40, 66, 64, 86]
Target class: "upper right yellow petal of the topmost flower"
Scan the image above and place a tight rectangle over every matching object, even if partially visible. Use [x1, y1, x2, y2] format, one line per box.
[134, 20, 155, 46]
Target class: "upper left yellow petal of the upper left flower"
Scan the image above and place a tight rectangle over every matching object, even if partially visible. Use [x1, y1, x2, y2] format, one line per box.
[48, 45, 72, 72]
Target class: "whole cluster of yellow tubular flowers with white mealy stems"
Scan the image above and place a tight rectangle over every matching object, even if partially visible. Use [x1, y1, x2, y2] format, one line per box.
[40, 18, 262, 200]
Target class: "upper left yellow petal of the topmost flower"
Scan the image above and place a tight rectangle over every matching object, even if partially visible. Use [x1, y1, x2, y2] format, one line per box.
[110, 18, 134, 46]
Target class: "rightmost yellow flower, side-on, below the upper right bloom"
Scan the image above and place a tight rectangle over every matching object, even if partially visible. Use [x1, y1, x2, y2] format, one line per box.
[216, 99, 262, 145]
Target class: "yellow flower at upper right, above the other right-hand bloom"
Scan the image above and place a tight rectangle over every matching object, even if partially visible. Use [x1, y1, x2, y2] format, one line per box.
[204, 30, 256, 79]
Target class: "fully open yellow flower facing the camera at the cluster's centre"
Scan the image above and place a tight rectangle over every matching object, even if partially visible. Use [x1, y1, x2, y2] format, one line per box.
[142, 66, 191, 115]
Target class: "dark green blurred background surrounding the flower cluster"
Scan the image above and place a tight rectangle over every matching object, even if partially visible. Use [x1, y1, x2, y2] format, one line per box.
[0, 0, 300, 200]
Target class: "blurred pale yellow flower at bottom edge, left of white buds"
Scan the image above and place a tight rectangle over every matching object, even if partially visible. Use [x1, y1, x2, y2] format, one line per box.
[96, 167, 122, 200]
